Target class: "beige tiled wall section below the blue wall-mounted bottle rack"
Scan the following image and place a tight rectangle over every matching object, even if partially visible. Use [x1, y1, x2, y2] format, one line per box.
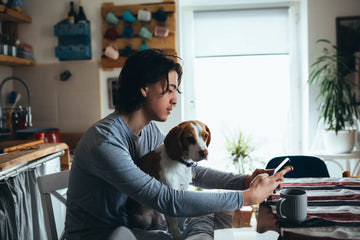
[14, 62, 101, 133]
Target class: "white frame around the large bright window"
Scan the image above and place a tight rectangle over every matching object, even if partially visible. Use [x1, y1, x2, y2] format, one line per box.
[179, 0, 308, 154]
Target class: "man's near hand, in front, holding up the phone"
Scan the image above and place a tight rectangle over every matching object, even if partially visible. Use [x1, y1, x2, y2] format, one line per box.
[243, 166, 294, 206]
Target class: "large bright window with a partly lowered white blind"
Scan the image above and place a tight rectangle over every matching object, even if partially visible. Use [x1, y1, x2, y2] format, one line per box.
[181, 4, 301, 170]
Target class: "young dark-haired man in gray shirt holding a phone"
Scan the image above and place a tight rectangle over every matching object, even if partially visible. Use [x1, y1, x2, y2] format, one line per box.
[65, 49, 291, 240]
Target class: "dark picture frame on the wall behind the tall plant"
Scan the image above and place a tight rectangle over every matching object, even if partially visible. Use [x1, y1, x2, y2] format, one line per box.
[336, 16, 360, 75]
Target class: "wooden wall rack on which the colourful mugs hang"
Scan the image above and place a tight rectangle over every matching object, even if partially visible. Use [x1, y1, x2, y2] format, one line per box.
[101, 0, 177, 70]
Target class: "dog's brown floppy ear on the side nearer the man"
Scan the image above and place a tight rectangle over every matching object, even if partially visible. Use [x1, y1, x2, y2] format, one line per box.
[164, 126, 182, 159]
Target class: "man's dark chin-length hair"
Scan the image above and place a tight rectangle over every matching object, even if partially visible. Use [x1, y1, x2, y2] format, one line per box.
[115, 49, 182, 113]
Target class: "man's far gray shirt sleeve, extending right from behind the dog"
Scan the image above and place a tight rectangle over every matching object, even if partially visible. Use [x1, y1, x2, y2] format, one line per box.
[192, 165, 247, 190]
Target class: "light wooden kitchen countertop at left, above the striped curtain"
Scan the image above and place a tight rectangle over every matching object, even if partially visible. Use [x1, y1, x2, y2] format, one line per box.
[0, 143, 70, 172]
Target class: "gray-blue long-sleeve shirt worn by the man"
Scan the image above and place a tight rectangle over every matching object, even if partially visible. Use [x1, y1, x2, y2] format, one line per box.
[65, 112, 245, 240]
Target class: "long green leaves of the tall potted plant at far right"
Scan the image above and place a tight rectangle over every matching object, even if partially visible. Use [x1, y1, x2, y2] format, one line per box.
[308, 39, 360, 133]
